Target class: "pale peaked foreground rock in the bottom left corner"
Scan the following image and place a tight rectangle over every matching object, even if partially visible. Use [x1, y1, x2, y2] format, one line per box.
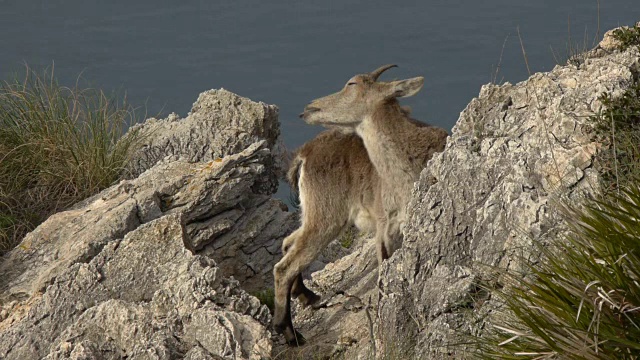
[0, 213, 270, 359]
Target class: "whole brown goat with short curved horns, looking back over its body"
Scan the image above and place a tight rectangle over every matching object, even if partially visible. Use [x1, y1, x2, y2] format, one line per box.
[273, 65, 448, 345]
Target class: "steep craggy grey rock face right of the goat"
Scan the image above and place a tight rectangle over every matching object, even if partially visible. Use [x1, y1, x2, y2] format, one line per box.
[377, 35, 640, 359]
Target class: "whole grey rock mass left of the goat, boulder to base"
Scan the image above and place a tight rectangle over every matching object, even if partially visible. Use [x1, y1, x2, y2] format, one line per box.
[0, 91, 297, 359]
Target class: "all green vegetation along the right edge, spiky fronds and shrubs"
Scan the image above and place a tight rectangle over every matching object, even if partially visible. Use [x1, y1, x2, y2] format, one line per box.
[478, 25, 640, 359]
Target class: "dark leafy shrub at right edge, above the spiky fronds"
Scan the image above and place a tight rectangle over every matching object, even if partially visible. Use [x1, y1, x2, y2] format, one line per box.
[590, 80, 640, 191]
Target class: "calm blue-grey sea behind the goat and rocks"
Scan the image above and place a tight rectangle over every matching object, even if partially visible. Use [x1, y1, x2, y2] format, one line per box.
[0, 0, 640, 197]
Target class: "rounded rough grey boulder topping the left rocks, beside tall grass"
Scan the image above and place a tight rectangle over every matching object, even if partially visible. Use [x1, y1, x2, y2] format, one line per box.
[126, 89, 286, 191]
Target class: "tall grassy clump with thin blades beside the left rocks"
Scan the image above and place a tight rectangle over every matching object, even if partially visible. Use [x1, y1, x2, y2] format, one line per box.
[0, 67, 140, 254]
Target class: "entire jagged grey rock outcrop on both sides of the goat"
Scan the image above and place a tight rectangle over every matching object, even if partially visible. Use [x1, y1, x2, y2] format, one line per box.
[0, 26, 640, 359]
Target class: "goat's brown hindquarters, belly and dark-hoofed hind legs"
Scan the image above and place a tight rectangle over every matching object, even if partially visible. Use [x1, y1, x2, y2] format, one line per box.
[273, 130, 384, 345]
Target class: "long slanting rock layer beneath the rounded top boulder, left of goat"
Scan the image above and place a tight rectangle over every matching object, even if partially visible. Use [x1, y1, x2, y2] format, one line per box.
[0, 141, 296, 302]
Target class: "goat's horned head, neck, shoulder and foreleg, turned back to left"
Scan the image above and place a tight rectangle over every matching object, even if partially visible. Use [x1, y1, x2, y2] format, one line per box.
[300, 65, 448, 256]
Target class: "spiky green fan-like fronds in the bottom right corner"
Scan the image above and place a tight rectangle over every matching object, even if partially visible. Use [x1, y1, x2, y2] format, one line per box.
[478, 188, 640, 359]
